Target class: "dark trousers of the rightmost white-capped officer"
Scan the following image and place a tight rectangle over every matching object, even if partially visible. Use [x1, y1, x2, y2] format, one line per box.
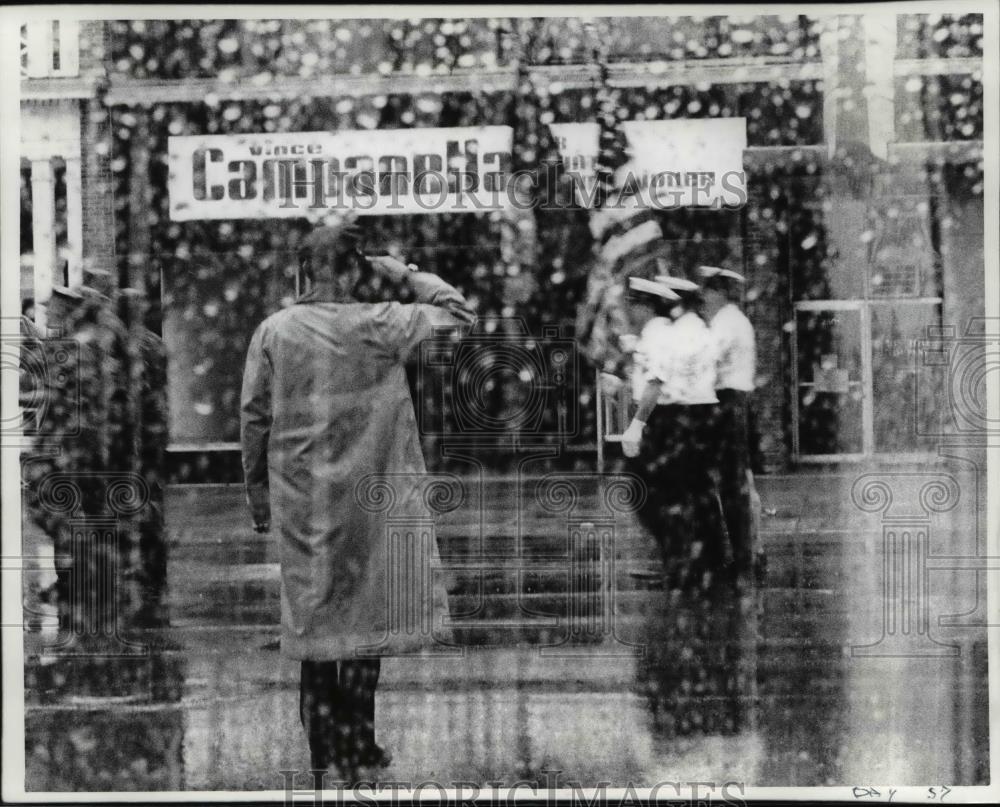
[716, 389, 753, 572]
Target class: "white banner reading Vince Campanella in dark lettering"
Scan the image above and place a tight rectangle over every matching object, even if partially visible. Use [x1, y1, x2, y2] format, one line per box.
[168, 126, 512, 221]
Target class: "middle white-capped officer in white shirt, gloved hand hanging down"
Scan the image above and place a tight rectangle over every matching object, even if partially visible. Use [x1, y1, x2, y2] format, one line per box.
[622, 276, 730, 589]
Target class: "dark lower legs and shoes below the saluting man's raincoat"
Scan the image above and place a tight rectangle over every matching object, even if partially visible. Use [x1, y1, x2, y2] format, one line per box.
[299, 659, 381, 779]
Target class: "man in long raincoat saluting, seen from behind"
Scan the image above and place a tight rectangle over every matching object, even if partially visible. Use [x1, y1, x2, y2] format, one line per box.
[241, 219, 474, 781]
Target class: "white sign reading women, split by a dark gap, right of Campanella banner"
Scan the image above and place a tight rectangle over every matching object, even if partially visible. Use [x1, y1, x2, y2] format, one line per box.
[551, 118, 747, 209]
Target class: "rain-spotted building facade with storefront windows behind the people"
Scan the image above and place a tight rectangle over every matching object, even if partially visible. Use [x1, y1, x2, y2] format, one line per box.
[21, 12, 985, 469]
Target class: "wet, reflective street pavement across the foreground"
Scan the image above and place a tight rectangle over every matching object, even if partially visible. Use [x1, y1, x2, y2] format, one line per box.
[25, 466, 988, 791]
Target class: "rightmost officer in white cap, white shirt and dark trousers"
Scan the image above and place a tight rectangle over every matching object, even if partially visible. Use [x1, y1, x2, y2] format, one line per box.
[698, 266, 756, 575]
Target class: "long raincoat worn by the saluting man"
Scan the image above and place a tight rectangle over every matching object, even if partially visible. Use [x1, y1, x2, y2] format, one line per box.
[241, 272, 474, 661]
